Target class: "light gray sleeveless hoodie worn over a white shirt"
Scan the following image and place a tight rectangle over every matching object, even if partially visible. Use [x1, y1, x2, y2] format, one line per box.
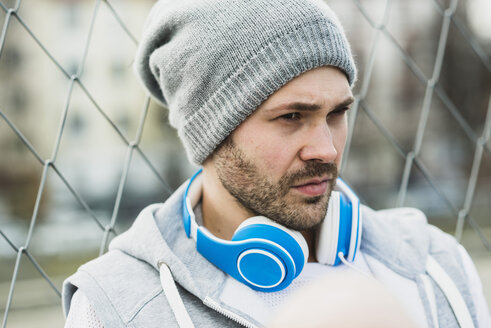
[63, 183, 478, 328]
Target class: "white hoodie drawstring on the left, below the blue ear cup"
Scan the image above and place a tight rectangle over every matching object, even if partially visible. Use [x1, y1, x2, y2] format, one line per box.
[158, 261, 194, 328]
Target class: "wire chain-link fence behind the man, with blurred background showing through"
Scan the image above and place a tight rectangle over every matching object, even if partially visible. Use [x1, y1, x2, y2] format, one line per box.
[0, 0, 491, 327]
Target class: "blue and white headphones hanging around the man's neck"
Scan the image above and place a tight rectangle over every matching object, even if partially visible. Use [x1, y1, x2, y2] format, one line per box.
[182, 169, 362, 292]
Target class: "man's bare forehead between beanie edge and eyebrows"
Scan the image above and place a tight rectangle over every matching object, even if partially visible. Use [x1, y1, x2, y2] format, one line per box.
[256, 66, 352, 111]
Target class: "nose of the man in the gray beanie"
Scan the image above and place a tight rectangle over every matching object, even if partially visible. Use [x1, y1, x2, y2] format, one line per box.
[300, 123, 338, 163]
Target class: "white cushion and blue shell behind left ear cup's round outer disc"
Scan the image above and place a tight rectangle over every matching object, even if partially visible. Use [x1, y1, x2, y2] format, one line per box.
[232, 216, 309, 277]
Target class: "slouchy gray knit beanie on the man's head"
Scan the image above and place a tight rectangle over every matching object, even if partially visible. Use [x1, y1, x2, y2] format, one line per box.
[135, 0, 356, 164]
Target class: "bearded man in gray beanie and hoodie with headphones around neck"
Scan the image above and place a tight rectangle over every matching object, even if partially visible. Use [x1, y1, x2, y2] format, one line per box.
[63, 0, 489, 327]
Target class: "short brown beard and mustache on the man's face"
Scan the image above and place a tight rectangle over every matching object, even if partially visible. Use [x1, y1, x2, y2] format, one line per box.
[214, 137, 338, 231]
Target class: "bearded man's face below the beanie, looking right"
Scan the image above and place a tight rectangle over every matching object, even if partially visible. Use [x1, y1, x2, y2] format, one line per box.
[213, 67, 353, 230]
